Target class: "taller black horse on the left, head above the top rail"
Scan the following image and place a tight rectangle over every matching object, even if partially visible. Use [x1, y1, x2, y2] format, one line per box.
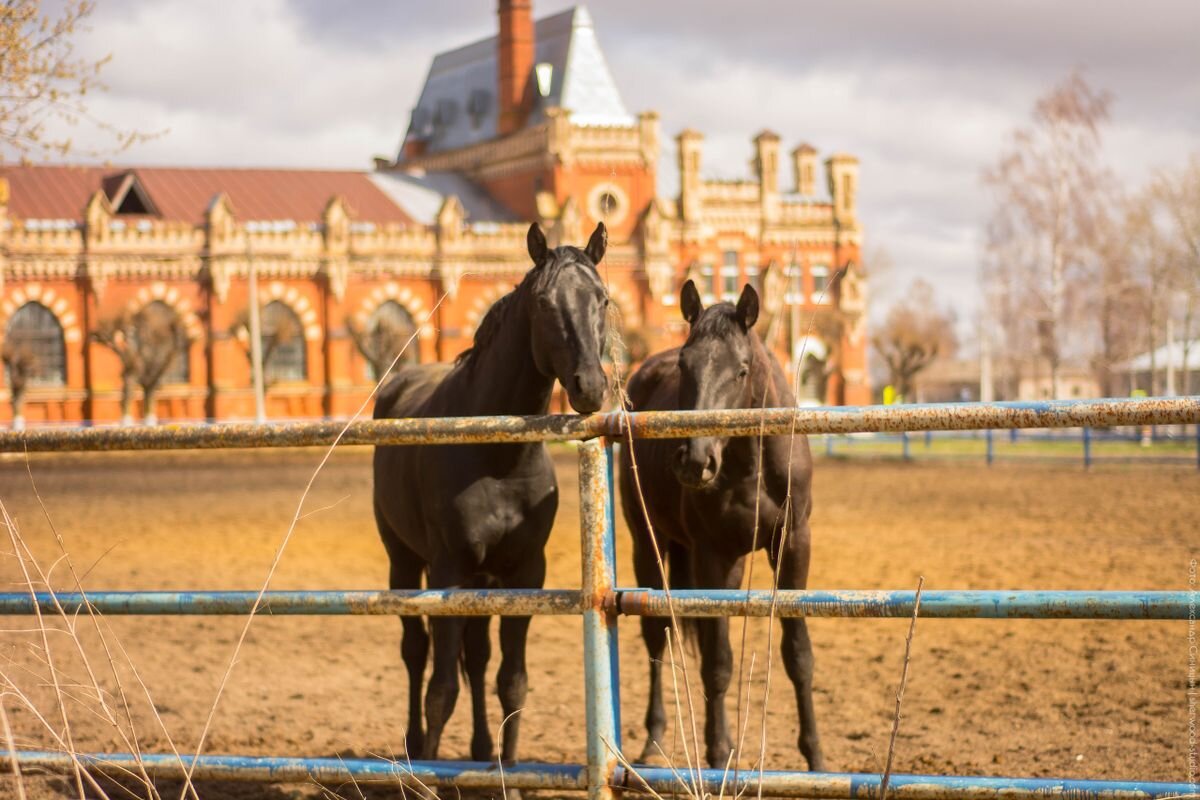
[374, 224, 608, 762]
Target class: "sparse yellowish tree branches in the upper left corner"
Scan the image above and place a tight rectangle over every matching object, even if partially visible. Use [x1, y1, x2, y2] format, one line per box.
[0, 0, 152, 158]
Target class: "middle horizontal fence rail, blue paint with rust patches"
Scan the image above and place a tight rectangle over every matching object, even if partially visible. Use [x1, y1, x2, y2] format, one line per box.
[0, 588, 1195, 620]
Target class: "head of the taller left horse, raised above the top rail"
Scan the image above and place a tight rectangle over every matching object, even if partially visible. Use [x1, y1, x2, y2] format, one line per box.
[527, 222, 608, 414]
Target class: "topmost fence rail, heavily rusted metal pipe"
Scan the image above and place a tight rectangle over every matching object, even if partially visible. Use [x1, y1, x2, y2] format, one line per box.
[0, 396, 1200, 452]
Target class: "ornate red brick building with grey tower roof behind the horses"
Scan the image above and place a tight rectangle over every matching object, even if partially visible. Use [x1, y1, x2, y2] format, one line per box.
[0, 0, 869, 423]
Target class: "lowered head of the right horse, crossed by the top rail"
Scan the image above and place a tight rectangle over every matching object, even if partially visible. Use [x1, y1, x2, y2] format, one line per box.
[671, 281, 758, 488]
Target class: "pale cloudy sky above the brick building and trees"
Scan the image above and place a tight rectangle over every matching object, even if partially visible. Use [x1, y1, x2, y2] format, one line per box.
[46, 0, 1200, 323]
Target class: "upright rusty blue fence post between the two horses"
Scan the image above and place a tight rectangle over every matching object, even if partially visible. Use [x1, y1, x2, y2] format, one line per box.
[580, 439, 620, 800]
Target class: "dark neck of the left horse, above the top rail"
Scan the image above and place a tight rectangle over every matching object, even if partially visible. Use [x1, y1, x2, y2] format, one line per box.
[451, 287, 554, 416]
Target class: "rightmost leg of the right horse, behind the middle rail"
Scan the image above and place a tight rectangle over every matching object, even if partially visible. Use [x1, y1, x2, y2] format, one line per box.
[775, 519, 824, 772]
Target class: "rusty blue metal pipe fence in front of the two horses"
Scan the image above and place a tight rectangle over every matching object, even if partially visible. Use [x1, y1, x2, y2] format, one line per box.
[0, 397, 1200, 800]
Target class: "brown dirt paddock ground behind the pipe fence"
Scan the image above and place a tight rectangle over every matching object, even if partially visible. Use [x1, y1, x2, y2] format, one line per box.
[0, 446, 1200, 800]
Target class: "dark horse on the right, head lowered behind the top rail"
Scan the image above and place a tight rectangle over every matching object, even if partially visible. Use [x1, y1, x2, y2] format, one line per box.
[619, 281, 823, 770]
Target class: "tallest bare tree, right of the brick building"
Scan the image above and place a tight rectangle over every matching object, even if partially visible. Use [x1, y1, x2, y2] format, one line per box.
[984, 72, 1111, 397]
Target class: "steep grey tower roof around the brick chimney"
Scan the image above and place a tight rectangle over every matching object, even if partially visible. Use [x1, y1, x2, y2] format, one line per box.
[401, 6, 635, 161]
